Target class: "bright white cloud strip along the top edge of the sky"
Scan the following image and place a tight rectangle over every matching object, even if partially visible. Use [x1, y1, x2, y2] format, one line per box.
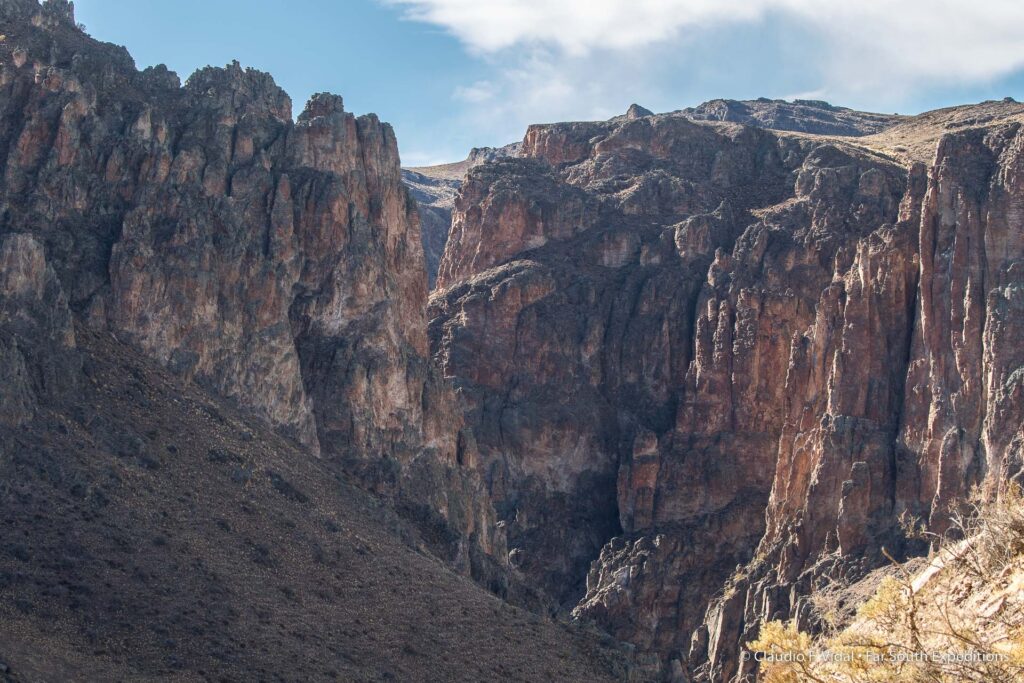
[384, 0, 1024, 87]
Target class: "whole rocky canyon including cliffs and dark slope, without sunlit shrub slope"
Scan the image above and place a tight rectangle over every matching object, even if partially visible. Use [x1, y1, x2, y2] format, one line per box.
[0, 0, 1024, 683]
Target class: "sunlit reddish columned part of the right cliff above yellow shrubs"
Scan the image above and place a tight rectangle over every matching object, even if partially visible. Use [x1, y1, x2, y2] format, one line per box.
[691, 118, 1024, 680]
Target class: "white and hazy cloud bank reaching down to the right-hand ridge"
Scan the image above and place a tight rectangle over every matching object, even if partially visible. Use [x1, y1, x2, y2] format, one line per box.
[381, 0, 1024, 156]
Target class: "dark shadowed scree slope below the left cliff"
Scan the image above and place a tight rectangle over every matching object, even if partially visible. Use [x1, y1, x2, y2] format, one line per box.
[0, 325, 618, 683]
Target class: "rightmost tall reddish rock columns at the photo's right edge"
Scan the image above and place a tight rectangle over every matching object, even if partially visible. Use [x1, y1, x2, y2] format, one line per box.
[900, 125, 1024, 526]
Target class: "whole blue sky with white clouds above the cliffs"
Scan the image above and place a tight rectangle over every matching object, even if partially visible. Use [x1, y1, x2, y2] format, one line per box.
[75, 0, 1024, 166]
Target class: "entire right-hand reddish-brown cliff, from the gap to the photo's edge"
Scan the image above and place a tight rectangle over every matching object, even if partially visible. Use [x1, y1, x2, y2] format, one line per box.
[431, 97, 1024, 680]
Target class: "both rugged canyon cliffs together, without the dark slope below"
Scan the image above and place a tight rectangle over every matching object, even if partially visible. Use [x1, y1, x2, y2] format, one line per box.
[0, 0, 1024, 681]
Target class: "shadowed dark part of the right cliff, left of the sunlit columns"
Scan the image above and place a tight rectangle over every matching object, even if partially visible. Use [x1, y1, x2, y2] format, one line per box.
[431, 117, 904, 614]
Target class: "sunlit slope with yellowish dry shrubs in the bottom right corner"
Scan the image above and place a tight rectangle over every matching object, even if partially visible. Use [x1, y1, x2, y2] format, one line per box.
[751, 486, 1024, 683]
